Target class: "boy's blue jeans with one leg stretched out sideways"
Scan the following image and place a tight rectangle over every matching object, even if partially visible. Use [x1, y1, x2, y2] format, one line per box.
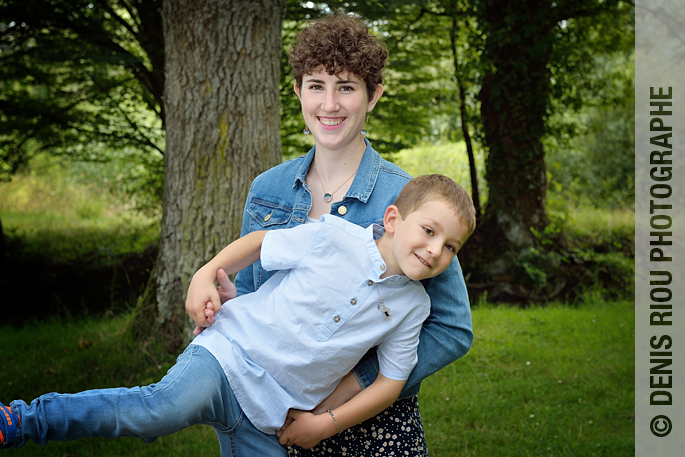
[10, 345, 288, 457]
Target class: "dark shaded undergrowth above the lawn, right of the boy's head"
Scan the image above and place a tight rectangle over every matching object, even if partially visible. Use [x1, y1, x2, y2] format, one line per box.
[458, 222, 635, 307]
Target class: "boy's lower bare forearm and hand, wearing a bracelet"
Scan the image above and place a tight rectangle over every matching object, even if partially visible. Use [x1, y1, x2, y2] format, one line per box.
[279, 374, 406, 449]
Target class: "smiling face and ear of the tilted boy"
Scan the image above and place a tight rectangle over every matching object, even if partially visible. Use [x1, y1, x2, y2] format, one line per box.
[386, 200, 468, 281]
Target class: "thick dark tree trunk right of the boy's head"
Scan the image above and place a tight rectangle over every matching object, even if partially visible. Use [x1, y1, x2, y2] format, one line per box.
[479, 0, 554, 275]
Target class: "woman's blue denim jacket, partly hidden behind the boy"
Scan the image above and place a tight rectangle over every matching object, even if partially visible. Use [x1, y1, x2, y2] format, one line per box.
[236, 140, 473, 398]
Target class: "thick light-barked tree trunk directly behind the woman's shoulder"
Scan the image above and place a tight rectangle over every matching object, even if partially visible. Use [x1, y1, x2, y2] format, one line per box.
[155, 0, 285, 337]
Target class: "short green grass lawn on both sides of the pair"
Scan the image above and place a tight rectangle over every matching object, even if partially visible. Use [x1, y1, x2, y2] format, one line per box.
[0, 299, 634, 457]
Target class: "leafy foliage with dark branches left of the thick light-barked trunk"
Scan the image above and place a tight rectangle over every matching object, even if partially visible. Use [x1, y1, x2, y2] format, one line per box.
[0, 0, 164, 180]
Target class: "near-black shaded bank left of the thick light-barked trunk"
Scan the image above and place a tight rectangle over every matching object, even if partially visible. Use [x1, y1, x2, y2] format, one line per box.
[0, 238, 157, 326]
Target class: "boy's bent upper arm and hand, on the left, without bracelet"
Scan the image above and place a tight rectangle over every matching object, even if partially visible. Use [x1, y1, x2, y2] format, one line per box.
[186, 230, 266, 327]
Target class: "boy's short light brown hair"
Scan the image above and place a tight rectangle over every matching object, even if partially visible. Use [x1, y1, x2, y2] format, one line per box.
[394, 175, 476, 236]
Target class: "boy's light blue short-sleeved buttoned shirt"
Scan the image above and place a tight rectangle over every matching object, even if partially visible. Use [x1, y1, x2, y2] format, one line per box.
[193, 215, 430, 434]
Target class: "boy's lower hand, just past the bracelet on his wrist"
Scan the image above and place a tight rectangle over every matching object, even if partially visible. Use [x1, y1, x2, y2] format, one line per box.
[277, 409, 337, 449]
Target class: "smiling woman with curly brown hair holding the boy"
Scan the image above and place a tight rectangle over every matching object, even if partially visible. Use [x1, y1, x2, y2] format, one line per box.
[224, 14, 473, 456]
